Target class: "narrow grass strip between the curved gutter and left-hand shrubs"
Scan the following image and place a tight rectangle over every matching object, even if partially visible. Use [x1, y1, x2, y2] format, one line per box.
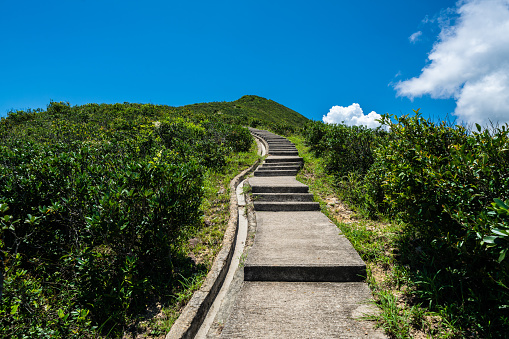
[124, 143, 259, 338]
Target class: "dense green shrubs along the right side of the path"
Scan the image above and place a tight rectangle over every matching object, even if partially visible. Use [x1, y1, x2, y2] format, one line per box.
[304, 112, 509, 338]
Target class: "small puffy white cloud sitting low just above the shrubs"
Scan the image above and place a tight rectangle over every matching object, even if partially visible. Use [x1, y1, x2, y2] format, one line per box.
[323, 103, 381, 128]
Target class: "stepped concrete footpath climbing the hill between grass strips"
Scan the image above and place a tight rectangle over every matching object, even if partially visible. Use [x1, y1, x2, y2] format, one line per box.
[202, 129, 385, 339]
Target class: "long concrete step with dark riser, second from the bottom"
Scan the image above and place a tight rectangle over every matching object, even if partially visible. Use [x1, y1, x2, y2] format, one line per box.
[244, 212, 366, 282]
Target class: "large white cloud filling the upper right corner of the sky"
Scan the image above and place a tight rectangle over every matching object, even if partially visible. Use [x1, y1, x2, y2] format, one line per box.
[395, 0, 509, 123]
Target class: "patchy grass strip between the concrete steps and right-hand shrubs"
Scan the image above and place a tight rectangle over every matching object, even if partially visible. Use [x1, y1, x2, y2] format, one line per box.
[289, 135, 462, 338]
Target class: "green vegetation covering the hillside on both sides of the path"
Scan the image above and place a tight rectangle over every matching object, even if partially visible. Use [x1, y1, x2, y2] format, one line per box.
[7, 96, 509, 338]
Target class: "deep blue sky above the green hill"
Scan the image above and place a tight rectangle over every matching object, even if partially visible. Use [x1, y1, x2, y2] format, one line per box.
[0, 0, 509, 127]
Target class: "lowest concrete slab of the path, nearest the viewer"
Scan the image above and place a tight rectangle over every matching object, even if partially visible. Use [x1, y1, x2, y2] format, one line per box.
[221, 281, 386, 339]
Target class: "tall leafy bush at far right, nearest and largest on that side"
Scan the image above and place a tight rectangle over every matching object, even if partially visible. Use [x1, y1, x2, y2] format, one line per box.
[366, 112, 509, 334]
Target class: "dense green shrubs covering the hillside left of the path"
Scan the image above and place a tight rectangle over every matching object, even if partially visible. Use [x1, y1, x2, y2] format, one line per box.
[0, 96, 305, 338]
